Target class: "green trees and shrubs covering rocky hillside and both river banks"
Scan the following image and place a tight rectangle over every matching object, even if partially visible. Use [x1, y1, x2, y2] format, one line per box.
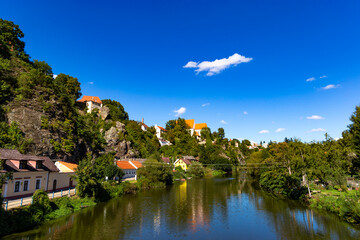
[0, 19, 360, 236]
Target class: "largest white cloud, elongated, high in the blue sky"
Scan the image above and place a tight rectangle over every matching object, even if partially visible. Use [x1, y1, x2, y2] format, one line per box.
[183, 53, 252, 76]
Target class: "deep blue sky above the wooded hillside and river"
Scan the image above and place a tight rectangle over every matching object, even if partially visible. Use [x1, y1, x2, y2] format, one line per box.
[0, 0, 360, 142]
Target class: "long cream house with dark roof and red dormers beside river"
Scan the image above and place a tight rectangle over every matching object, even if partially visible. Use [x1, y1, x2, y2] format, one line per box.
[0, 149, 74, 199]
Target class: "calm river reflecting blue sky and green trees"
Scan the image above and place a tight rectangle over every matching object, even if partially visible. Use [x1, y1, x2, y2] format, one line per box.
[5, 178, 360, 240]
